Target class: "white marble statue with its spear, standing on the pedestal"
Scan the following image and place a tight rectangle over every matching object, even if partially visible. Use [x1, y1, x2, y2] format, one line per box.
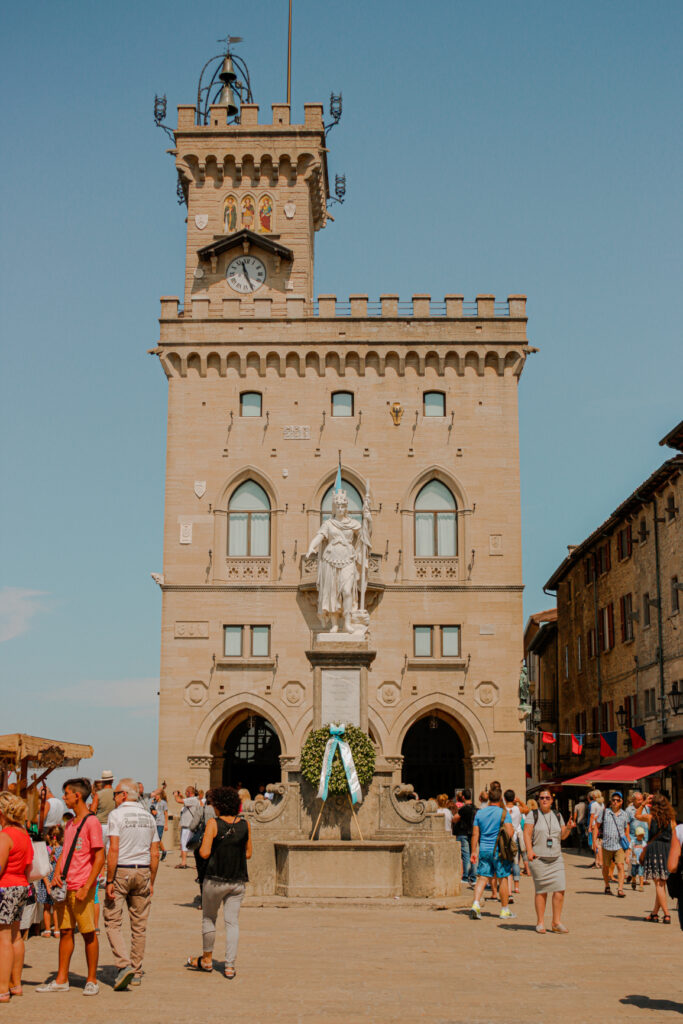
[306, 485, 372, 636]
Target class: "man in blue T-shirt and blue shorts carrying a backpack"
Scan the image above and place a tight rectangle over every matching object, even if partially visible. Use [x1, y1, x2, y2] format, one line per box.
[470, 783, 517, 921]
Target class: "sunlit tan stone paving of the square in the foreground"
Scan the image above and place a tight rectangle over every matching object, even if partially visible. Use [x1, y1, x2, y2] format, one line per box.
[6, 854, 683, 1024]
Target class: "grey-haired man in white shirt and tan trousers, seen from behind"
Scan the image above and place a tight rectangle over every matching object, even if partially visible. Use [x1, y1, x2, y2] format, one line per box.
[104, 778, 159, 991]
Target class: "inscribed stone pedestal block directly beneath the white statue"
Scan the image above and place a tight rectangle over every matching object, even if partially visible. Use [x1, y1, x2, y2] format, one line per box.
[306, 633, 377, 732]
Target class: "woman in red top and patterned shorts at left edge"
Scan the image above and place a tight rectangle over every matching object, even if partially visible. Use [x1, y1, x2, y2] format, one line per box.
[0, 791, 33, 1002]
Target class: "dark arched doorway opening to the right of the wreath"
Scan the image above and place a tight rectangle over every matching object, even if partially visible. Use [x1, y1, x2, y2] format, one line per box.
[401, 712, 465, 800]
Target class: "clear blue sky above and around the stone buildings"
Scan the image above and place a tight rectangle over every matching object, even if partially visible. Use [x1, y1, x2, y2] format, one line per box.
[0, 0, 683, 782]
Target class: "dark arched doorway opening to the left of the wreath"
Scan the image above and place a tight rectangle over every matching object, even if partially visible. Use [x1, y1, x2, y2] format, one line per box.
[223, 715, 282, 797]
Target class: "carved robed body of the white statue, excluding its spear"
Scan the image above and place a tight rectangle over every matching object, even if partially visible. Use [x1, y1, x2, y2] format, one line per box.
[306, 490, 364, 633]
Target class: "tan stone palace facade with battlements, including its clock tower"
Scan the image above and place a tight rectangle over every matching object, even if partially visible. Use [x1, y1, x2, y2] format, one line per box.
[152, 83, 528, 838]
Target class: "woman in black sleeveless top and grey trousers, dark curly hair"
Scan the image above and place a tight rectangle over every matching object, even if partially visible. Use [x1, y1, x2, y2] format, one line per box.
[187, 786, 252, 979]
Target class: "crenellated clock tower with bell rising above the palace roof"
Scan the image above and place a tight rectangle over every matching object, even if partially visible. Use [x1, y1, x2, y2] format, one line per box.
[171, 52, 329, 317]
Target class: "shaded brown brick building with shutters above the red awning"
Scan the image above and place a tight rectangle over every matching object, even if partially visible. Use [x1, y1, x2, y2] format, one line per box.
[546, 424, 683, 799]
